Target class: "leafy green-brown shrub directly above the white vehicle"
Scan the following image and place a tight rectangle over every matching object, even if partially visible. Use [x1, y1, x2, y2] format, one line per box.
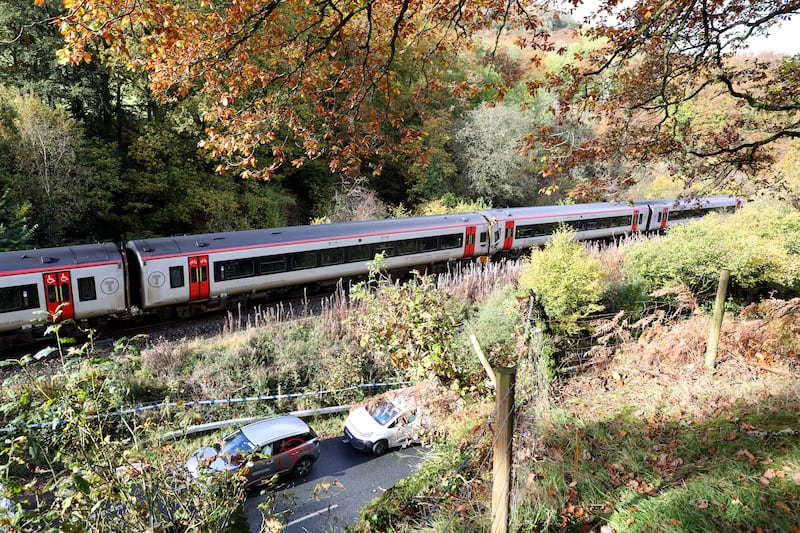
[350, 256, 469, 387]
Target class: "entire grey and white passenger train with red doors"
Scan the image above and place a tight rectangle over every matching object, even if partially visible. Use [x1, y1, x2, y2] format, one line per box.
[0, 196, 743, 347]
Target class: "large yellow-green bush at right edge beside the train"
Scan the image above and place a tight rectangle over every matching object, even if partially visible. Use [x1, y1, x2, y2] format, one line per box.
[623, 202, 800, 295]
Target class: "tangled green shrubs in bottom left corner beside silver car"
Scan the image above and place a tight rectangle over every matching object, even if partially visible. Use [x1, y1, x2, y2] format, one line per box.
[0, 330, 244, 531]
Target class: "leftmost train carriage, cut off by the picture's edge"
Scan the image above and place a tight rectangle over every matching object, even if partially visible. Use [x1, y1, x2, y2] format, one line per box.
[0, 243, 127, 332]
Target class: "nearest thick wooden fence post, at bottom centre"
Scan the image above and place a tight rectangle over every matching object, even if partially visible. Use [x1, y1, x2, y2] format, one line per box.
[491, 367, 516, 533]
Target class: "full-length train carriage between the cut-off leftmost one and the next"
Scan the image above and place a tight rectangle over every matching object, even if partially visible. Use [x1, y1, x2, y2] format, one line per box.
[127, 213, 489, 310]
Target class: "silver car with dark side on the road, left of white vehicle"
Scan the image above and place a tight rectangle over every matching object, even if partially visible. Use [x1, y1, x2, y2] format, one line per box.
[186, 415, 319, 487]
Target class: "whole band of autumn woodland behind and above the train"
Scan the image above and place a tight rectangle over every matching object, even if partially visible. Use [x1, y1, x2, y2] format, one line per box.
[0, 0, 800, 249]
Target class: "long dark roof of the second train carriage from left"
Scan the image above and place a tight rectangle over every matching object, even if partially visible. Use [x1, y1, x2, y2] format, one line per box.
[127, 213, 487, 258]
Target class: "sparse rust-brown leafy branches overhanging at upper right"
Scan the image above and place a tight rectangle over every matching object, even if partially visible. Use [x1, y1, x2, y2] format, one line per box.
[549, 0, 800, 200]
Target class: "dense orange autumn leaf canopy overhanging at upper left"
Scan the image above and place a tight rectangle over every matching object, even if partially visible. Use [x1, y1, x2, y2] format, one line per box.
[53, 0, 552, 177]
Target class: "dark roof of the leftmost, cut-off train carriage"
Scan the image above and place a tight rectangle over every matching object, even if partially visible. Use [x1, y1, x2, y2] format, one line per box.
[0, 242, 122, 275]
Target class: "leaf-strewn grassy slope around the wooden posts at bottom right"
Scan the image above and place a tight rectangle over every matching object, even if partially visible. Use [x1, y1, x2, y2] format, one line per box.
[354, 312, 800, 532]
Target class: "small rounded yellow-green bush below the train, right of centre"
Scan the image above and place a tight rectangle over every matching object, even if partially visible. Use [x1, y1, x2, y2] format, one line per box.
[519, 228, 603, 334]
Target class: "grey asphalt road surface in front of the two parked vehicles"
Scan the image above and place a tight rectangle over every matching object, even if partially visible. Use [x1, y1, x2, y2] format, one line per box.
[245, 438, 428, 533]
